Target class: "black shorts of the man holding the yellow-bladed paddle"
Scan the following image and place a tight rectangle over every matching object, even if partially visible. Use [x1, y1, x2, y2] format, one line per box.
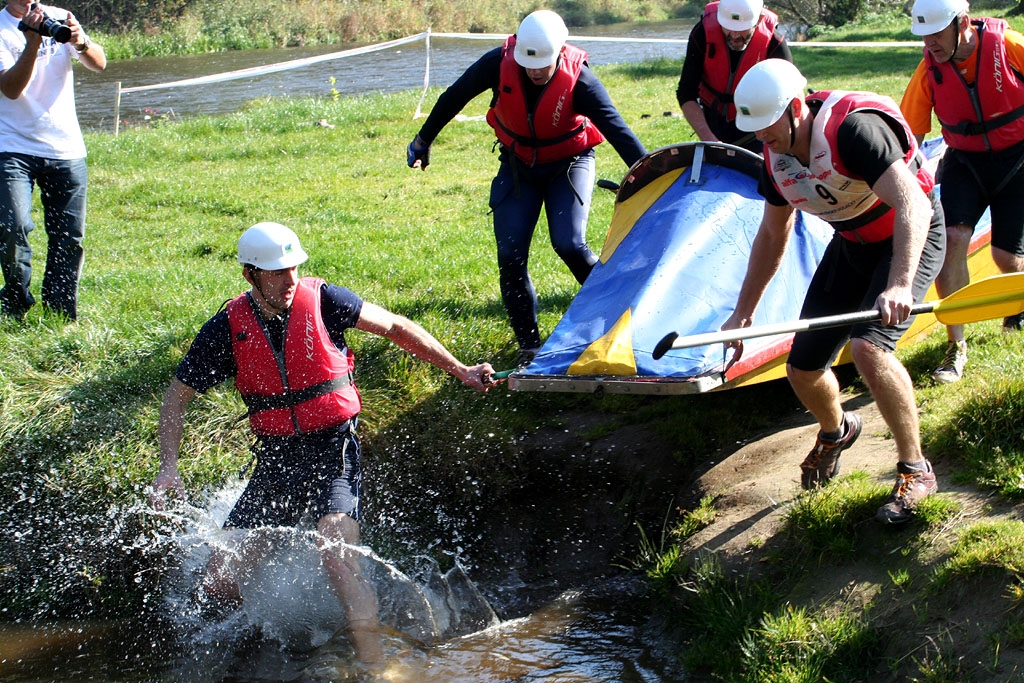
[787, 194, 946, 372]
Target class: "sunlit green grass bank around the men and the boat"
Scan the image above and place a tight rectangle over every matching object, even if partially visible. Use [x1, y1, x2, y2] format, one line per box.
[0, 21, 1024, 681]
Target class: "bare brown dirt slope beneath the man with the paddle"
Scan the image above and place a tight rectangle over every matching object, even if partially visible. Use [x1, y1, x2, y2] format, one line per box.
[667, 387, 1024, 682]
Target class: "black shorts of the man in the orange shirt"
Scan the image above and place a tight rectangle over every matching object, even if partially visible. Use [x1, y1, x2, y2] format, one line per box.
[939, 143, 1024, 256]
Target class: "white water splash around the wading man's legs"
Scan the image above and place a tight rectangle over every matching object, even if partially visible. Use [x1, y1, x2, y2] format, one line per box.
[143, 481, 499, 681]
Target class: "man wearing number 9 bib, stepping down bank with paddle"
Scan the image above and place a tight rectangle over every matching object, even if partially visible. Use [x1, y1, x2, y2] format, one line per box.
[722, 59, 945, 524]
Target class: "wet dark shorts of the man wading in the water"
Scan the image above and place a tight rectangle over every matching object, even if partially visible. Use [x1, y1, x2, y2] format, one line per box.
[224, 420, 361, 528]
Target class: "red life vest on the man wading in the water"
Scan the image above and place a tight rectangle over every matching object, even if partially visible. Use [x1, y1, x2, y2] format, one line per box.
[227, 278, 361, 436]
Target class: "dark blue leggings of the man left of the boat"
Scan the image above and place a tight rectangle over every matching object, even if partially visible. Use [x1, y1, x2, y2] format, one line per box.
[490, 150, 597, 348]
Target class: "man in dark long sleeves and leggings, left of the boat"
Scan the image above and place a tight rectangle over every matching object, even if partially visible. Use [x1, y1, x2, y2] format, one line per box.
[407, 9, 646, 367]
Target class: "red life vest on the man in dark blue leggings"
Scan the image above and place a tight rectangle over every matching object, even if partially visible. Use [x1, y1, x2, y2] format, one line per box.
[487, 36, 604, 166]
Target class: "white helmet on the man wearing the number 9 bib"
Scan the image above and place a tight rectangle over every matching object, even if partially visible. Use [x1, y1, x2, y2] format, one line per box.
[732, 59, 807, 132]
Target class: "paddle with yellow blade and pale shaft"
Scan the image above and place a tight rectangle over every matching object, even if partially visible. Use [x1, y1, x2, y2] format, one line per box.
[652, 272, 1024, 360]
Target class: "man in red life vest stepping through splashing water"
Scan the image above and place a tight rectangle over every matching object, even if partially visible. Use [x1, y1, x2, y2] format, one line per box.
[151, 223, 494, 664]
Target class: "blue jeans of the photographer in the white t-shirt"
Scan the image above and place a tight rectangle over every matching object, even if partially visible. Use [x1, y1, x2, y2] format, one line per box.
[0, 153, 88, 319]
